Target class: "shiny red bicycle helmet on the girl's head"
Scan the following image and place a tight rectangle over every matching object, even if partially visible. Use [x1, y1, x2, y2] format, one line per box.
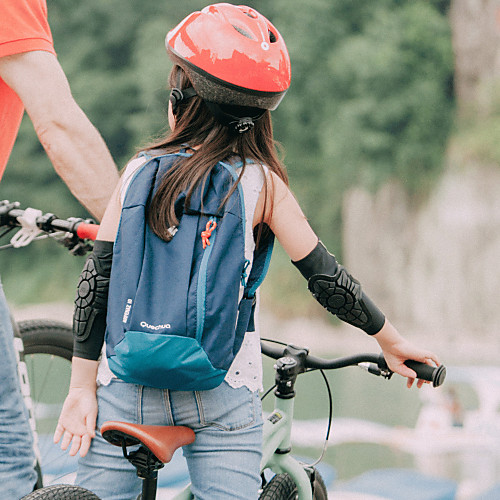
[165, 3, 291, 110]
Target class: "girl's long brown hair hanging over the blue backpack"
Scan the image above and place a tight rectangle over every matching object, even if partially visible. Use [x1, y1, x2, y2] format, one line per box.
[141, 65, 288, 241]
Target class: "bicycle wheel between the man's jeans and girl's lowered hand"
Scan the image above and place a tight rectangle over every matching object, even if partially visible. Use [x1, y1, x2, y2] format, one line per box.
[16, 320, 77, 486]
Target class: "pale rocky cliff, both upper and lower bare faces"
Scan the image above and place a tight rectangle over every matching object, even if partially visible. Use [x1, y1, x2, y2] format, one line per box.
[343, 0, 500, 340]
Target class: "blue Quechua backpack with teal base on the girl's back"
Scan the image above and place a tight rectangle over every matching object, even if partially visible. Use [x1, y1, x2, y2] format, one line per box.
[106, 150, 274, 390]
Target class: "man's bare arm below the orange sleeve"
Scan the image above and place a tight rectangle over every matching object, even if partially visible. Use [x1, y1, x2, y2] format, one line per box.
[0, 51, 118, 220]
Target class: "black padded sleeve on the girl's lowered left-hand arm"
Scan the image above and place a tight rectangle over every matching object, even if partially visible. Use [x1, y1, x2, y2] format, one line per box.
[73, 240, 113, 361]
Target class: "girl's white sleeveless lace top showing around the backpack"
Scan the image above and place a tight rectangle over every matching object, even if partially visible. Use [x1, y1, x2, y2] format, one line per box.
[97, 154, 266, 391]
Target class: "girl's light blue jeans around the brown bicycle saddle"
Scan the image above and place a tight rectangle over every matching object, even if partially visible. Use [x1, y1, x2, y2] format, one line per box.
[76, 379, 262, 500]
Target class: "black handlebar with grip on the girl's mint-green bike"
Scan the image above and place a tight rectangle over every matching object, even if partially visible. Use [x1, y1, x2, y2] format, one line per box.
[261, 342, 446, 387]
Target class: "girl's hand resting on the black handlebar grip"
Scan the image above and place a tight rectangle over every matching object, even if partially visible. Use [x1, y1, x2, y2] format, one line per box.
[374, 320, 440, 388]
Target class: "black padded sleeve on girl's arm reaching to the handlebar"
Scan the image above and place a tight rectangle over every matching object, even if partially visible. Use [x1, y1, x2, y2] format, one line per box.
[292, 241, 385, 335]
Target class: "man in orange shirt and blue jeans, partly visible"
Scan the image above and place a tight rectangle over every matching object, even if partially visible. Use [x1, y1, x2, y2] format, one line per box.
[0, 0, 118, 500]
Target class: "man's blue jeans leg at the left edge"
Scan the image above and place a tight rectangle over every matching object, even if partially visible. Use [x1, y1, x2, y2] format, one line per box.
[0, 283, 37, 500]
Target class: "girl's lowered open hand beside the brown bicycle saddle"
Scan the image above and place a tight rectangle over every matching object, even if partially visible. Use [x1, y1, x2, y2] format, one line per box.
[54, 388, 97, 457]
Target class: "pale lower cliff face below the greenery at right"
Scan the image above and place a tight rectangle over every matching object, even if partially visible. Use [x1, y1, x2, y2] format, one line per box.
[344, 163, 500, 338]
